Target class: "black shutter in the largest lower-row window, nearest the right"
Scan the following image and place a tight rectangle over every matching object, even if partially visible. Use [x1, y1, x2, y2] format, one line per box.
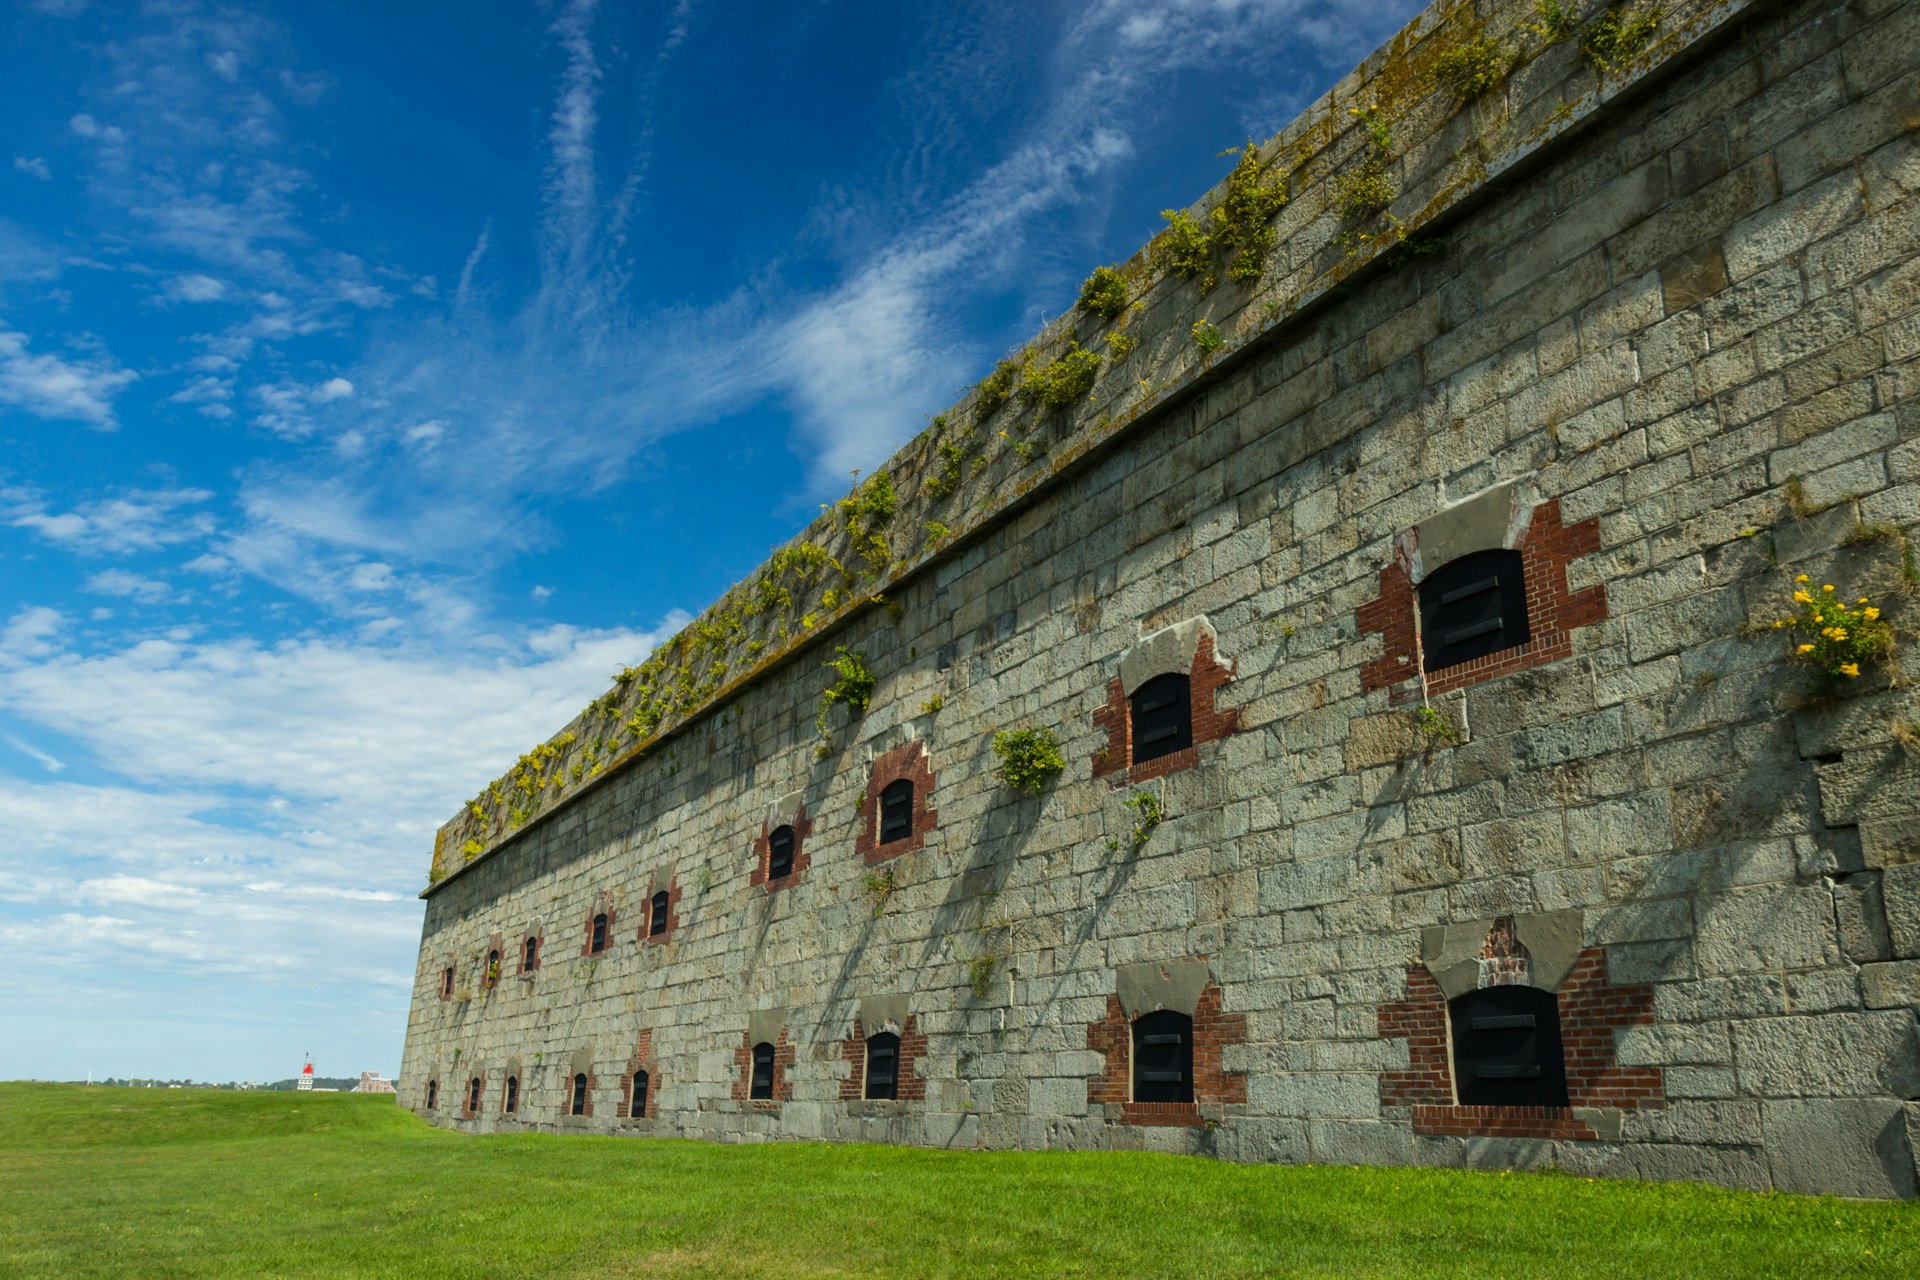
[1448, 986, 1567, 1107]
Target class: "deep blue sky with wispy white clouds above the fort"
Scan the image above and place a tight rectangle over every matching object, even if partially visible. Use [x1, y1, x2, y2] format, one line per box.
[0, 0, 1417, 1080]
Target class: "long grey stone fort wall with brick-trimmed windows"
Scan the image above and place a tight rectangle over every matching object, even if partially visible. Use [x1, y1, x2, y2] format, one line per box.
[401, 0, 1920, 1196]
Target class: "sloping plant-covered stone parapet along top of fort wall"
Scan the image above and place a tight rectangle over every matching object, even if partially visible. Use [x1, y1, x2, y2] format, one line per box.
[420, 0, 1772, 896]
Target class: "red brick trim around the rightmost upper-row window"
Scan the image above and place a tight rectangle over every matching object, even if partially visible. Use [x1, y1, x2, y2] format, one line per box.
[1356, 497, 1607, 702]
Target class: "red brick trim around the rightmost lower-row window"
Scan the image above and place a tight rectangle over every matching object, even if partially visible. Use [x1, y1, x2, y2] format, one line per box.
[1379, 946, 1667, 1142]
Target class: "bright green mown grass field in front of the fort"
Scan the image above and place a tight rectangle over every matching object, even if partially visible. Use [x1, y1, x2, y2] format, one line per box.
[0, 1084, 1920, 1280]
